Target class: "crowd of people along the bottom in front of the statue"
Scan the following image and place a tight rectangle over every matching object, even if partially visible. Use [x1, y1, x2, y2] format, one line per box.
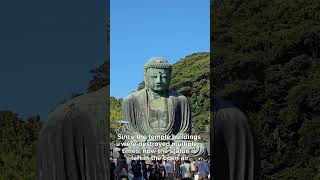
[111, 156, 210, 180]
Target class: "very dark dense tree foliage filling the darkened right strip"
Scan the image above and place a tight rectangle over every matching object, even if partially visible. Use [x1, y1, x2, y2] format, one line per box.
[211, 0, 320, 180]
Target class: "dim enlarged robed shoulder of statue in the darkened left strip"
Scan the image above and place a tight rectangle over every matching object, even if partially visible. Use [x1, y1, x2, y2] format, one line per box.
[37, 87, 109, 180]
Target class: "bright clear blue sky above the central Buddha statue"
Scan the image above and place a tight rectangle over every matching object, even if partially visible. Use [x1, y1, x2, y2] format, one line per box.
[110, 0, 210, 98]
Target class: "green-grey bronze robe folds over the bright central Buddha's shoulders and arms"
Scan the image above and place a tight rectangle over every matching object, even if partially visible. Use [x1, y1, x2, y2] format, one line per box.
[122, 88, 191, 137]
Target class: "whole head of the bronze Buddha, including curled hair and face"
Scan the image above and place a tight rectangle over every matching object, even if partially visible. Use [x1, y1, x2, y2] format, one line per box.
[144, 57, 172, 93]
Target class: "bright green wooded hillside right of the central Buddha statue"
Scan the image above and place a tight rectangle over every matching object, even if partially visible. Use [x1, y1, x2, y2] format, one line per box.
[170, 53, 210, 142]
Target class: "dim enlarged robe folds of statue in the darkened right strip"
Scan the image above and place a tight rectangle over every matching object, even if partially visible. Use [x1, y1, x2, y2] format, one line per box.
[210, 98, 260, 180]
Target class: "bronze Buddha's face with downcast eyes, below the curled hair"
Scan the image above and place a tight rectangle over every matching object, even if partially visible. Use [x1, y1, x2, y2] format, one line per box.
[145, 68, 171, 93]
